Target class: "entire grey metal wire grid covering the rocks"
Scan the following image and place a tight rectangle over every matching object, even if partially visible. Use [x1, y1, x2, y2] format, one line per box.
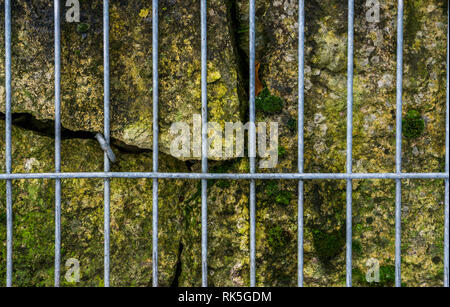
[0, 0, 450, 287]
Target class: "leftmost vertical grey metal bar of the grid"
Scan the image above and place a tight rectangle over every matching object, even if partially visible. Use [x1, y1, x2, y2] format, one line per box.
[5, 0, 13, 287]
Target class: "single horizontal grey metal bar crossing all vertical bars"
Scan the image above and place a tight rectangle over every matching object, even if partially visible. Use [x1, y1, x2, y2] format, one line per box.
[0, 172, 449, 180]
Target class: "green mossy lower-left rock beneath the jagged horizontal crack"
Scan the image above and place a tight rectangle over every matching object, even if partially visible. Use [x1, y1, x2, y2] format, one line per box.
[0, 121, 197, 286]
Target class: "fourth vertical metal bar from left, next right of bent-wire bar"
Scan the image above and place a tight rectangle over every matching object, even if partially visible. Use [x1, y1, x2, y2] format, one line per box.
[152, 0, 159, 287]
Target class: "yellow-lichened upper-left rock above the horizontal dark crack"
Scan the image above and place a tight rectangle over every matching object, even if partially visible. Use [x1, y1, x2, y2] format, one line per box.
[0, 0, 242, 159]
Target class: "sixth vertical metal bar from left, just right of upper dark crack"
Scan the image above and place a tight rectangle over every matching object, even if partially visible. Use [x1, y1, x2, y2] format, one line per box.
[249, 0, 256, 287]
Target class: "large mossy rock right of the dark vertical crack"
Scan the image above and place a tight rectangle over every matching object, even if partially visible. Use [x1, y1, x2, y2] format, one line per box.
[234, 0, 447, 285]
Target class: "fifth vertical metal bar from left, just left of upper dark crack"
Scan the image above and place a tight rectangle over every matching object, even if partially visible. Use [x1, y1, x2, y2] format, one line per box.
[200, 0, 208, 287]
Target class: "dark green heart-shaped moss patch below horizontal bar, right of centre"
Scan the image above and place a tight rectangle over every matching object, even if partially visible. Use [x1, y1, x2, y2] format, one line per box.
[312, 229, 345, 263]
